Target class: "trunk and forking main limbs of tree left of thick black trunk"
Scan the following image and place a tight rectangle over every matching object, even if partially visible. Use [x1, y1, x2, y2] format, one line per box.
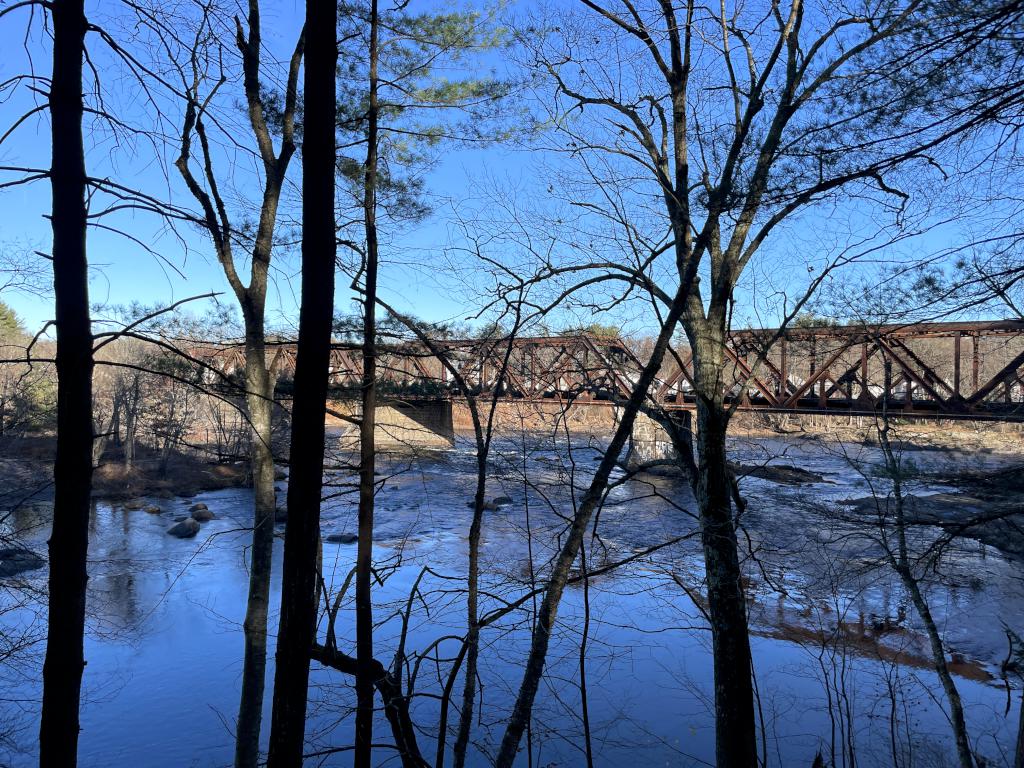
[168, 0, 299, 768]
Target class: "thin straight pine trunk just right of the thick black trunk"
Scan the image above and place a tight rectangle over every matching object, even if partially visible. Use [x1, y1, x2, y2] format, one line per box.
[354, 0, 378, 768]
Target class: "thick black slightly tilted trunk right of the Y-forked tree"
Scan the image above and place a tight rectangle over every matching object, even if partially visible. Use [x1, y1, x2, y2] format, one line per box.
[267, 0, 338, 757]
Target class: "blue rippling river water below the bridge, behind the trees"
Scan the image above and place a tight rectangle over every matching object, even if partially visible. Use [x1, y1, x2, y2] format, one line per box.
[0, 437, 1024, 768]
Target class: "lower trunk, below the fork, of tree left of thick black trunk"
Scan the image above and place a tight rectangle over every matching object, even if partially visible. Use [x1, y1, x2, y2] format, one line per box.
[234, 342, 276, 768]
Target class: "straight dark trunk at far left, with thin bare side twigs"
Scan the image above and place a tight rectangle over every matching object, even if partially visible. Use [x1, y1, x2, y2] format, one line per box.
[39, 0, 93, 768]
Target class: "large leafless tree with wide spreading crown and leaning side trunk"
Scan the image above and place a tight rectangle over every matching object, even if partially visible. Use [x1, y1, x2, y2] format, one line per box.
[477, 0, 1019, 766]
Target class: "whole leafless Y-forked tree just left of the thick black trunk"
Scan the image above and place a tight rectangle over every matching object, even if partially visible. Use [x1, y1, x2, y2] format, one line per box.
[127, 0, 303, 767]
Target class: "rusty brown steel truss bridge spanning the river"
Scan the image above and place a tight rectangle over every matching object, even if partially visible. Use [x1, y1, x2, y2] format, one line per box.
[197, 321, 1024, 422]
